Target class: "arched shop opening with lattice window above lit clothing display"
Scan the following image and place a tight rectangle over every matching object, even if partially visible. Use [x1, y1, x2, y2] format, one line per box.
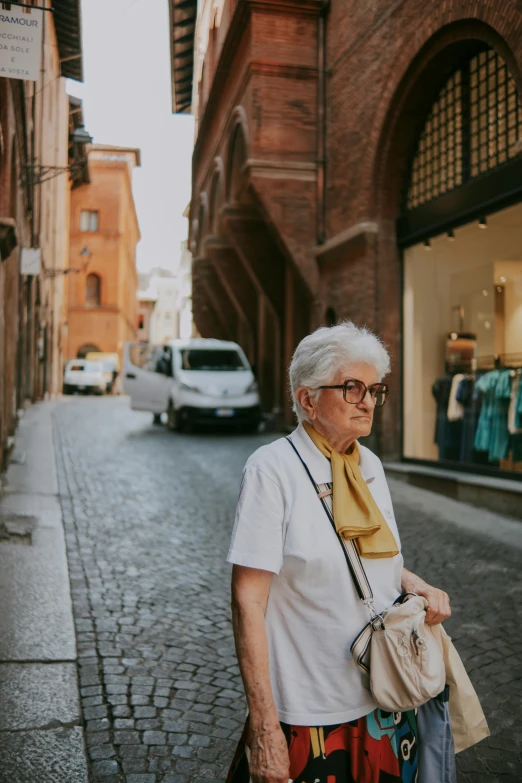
[390, 41, 522, 478]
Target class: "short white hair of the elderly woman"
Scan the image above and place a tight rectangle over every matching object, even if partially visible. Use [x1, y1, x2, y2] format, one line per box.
[289, 321, 390, 421]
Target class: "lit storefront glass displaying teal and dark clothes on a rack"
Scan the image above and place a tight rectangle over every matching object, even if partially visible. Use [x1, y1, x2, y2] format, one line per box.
[404, 204, 522, 473]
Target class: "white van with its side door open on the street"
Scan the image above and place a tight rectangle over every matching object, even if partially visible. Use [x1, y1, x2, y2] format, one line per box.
[123, 339, 261, 432]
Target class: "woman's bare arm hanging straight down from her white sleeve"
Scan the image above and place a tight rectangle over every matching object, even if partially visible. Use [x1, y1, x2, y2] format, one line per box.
[232, 565, 289, 783]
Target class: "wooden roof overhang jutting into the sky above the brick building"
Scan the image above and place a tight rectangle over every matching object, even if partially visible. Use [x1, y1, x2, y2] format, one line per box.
[169, 0, 198, 114]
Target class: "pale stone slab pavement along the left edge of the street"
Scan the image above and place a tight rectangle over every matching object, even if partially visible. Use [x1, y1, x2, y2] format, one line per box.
[0, 405, 87, 783]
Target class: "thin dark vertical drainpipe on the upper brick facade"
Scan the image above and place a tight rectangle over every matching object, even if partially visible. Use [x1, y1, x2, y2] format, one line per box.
[317, 0, 330, 245]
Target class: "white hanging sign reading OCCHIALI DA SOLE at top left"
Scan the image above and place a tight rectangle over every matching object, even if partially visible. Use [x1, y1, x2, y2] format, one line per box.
[0, 4, 44, 82]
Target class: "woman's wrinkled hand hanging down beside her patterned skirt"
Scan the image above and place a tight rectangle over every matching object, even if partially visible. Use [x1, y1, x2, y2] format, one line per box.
[249, 725, 290, 783]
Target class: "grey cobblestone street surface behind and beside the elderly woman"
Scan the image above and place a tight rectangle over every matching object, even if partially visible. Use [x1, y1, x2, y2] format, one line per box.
[51, 398, 522, 783]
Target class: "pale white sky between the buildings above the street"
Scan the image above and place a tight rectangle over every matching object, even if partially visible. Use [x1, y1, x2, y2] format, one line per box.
[67, 0, 194, 271]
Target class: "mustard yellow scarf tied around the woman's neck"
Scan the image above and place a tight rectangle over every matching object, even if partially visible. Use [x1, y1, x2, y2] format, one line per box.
[304, 421, 399, 557]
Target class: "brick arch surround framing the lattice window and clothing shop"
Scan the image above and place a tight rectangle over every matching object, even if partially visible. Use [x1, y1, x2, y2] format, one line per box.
[367, 16, 522, 458]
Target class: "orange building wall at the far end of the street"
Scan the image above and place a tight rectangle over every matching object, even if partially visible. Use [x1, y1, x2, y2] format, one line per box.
[65, 152, 140, 370]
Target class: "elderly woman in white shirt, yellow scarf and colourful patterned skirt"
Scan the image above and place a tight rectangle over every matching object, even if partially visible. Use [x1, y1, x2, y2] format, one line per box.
[228, 322, 450, 783]
